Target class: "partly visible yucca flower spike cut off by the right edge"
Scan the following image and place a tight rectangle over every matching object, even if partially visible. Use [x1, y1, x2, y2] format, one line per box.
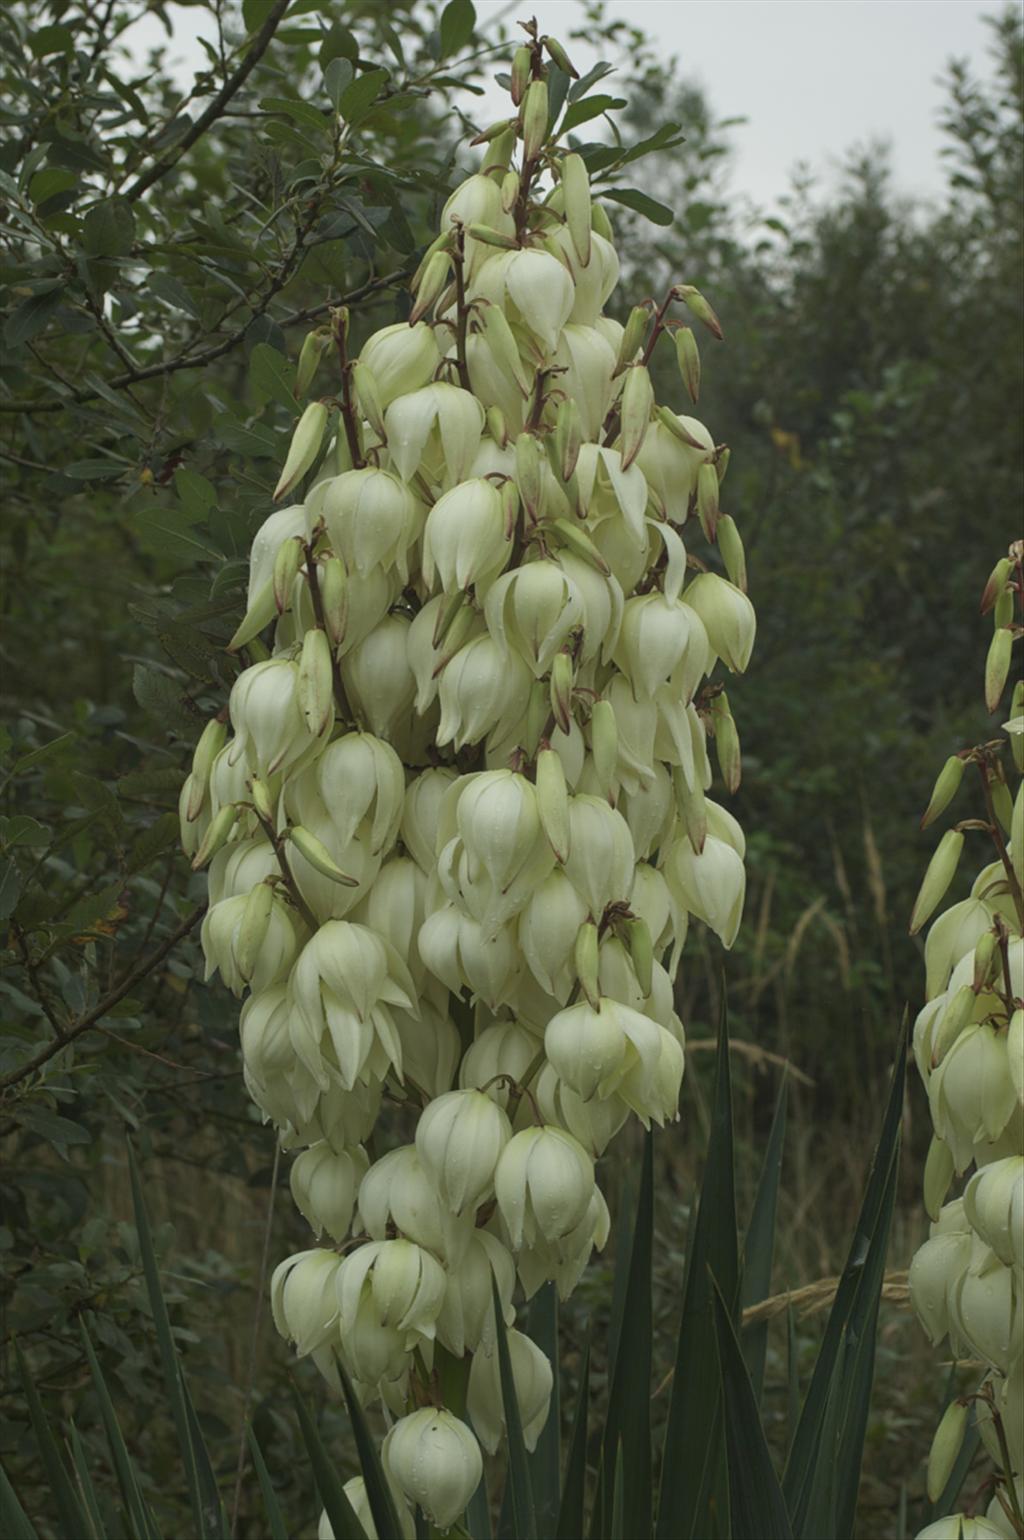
[910, 542, 1024, 1537]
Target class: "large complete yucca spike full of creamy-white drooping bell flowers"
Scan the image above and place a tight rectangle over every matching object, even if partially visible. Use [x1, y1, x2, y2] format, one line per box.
[182, 37, 755, 1528]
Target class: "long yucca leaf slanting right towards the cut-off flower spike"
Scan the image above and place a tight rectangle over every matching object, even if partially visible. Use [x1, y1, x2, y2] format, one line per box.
[782, 1023, 907, 1534]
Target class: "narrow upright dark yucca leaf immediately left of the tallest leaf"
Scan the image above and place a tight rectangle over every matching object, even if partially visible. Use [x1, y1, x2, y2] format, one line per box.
[602, 1132, 654, 1537]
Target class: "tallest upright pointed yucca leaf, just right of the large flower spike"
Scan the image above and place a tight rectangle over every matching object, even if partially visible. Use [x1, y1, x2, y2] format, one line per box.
[656, 992, 739, 1540]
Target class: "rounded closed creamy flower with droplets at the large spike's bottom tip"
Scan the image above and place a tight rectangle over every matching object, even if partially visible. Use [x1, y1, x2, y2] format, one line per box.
[382, 1406, 484, 1529]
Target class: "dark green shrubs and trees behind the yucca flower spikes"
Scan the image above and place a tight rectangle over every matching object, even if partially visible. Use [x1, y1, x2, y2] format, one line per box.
[0, 0, 1024, 1535]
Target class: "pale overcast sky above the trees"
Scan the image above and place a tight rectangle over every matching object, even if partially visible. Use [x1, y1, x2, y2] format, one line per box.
[132, 0, 999, 217]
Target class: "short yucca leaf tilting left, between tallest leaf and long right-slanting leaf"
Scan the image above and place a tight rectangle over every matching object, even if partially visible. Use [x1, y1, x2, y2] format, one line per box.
[713, 1284, 793, 1540]
